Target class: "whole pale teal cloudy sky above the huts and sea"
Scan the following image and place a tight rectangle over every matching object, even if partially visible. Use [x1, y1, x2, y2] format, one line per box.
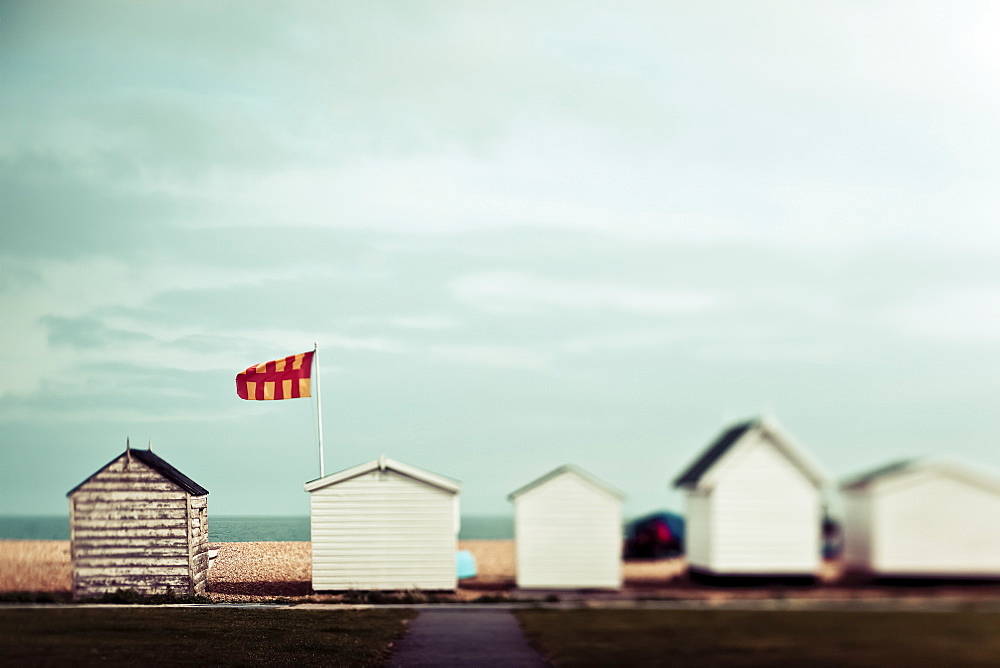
[0, 0, 1000, 515]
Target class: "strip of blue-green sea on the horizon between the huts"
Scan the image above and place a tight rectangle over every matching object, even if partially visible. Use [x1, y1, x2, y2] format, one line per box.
[0, 515, 514, 543]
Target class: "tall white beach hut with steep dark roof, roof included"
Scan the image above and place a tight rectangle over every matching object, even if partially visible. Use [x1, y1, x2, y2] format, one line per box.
[674, 418, 826, 577]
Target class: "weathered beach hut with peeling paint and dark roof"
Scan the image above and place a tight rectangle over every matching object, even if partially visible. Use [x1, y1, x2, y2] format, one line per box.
[67, 447, 208, 599]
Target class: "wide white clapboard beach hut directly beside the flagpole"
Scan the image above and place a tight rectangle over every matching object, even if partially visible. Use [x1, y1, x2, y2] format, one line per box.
[305, 456, 459, 591]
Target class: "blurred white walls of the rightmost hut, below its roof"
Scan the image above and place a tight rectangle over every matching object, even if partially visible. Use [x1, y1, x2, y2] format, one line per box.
[845, 469, 1000, 577]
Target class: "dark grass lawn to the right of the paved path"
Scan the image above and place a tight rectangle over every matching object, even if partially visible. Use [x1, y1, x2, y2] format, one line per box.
[517, 610, 1000, 667]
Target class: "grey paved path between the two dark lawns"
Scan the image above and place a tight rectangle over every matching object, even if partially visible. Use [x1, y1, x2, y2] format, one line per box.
[389, 609, 548, 668]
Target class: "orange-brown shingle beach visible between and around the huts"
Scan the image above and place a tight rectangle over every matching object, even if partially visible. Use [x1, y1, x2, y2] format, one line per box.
[0, 540, 1000, 601]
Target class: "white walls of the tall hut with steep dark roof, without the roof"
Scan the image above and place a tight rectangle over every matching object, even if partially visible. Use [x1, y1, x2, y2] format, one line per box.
[687, 433, 823, 575]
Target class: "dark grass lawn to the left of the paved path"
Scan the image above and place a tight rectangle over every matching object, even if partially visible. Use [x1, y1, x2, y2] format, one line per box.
[0, 607, 415, 666]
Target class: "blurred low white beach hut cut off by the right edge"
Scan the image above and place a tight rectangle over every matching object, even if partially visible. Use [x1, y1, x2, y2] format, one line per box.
[841, 458, 1000, 578]
